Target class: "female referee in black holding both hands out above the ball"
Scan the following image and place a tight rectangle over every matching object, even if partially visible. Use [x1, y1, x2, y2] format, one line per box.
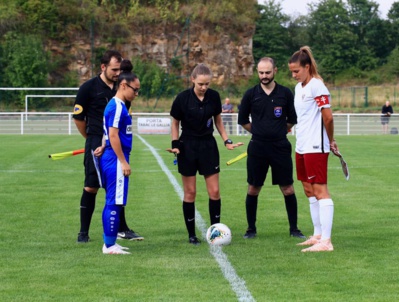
[167, 63, 242, 245]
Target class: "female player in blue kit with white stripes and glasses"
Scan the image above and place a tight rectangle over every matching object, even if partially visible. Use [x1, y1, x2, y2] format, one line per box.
[95, 60, 140, 254]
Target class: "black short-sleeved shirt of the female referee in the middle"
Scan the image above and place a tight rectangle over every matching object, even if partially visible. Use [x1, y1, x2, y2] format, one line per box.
[170, 88, 222, 137]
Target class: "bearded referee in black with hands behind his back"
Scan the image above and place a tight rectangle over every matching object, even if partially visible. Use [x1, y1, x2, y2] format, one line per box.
[238, 57, 306, 239]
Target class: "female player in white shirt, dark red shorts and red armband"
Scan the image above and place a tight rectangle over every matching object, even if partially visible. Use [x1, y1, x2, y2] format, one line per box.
[289, 46, 338, 252]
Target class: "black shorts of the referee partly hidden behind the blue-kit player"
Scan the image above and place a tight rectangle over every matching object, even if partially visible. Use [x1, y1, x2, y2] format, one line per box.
[83, 135, 103, 188]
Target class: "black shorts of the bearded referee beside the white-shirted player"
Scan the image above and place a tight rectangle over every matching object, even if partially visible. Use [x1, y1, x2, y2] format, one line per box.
[247, 139, 294, 187]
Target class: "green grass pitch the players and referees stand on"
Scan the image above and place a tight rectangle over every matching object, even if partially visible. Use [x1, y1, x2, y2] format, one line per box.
[0, 135, 399, 302]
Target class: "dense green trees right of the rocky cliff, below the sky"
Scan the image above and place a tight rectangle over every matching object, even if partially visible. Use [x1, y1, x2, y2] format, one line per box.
[253, 0, 399, 86]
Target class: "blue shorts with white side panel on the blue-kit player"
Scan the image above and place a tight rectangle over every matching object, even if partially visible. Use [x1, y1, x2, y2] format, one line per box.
[100, 149, 129, 206]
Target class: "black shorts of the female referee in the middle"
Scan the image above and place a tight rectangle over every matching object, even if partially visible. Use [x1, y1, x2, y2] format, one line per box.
[177, 136, 220, 176]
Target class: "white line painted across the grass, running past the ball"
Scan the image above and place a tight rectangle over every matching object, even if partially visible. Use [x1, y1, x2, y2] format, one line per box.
[135, 134, 255, 302]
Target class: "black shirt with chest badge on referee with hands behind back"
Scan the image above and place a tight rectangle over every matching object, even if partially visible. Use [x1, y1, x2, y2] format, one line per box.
[238, 83, 297, 141]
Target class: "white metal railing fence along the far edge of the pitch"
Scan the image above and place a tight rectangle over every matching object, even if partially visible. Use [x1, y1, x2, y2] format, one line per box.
[0, 112, 399, 135]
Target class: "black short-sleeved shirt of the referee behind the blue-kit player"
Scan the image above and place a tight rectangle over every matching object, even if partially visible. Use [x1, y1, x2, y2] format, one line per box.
[72, 75, 116, 136]
